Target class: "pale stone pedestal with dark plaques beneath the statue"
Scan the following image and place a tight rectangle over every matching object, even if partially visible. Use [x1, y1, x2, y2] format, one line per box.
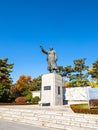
[41, 73, 63, 106]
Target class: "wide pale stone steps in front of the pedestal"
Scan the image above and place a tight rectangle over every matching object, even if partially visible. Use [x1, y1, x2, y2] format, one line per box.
[0, 106, 98, 130]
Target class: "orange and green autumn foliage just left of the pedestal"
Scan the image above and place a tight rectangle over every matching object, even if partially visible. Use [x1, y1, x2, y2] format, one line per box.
[15, 75, 41, 97]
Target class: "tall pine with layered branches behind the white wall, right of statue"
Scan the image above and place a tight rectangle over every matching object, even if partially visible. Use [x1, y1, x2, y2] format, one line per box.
[68, 58, 89, 86]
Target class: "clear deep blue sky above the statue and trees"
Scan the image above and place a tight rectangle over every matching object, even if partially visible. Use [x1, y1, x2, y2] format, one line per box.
[0, 0, 98, 82]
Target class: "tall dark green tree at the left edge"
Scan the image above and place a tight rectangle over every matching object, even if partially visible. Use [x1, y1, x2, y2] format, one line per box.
[0, 58, 13, 102]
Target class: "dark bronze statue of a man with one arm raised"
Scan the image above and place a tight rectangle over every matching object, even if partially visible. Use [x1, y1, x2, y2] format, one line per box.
[40, 46, 57, 73]
